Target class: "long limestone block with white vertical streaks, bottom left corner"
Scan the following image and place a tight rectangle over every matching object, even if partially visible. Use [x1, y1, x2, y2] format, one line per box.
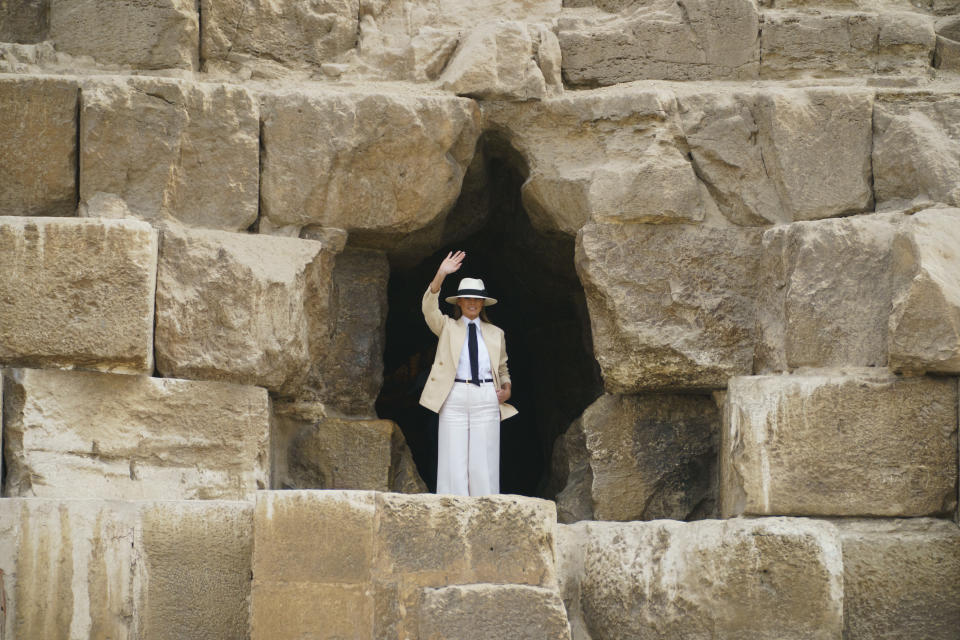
[0, 498, 253, 640]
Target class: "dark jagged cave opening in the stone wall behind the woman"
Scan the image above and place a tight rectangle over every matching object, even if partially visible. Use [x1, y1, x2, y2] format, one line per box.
[376, 140, 602, 498]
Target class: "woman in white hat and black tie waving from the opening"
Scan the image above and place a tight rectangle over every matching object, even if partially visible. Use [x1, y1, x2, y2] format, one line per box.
[420, 251, 517, 496]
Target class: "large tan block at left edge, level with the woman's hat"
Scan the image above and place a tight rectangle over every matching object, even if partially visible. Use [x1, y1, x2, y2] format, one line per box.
[0, 216, 157, 373]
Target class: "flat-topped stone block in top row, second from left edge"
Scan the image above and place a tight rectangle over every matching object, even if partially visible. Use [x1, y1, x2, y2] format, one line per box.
[49, 0, 200, 70]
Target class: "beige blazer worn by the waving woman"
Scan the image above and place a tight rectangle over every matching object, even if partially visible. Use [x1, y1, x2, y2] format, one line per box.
[420, 287, 517, 420]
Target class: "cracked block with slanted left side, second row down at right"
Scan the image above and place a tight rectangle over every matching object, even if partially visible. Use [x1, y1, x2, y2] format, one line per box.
[678, 89, 873, 225]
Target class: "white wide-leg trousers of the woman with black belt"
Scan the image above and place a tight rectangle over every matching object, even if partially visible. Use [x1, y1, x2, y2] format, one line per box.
[437, 382, 500, 496]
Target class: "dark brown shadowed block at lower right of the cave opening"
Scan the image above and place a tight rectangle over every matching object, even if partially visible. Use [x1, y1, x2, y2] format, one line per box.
[557, 394, 720, 522]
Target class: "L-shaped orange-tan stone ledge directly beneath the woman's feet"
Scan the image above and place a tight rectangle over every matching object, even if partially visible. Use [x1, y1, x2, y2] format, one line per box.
[251, 491, 556, 640]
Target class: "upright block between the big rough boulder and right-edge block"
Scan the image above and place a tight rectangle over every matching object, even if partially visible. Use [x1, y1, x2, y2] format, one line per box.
[756, 214, 904, 372]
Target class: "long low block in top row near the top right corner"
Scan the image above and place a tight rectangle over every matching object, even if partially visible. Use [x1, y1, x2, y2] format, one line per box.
[760, 10, 936, 78]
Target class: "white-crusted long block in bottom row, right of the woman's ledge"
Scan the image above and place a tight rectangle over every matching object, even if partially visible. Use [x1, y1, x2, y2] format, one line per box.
[559, 518, 843, 640]
